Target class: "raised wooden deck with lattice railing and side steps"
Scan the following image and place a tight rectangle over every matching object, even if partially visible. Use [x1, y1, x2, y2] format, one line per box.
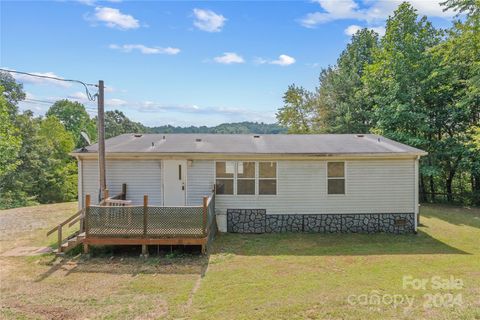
[48, 188, 217, 254]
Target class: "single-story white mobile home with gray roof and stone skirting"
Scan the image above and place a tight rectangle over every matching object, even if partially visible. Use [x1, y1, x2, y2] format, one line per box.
[73, 134, 426, 233]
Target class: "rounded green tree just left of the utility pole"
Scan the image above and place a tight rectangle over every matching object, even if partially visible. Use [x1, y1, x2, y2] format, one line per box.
[46, 99, 97, 148]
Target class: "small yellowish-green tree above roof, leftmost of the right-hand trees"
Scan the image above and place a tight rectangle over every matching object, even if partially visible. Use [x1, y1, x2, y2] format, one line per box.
[277, 84, 317, 133]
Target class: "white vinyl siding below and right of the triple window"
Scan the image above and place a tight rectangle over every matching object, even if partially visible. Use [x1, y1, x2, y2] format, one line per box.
[216, 159, 415, 214]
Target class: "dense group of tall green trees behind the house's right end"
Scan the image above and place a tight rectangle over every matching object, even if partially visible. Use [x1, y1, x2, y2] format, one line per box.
[277, 0, 480, 205]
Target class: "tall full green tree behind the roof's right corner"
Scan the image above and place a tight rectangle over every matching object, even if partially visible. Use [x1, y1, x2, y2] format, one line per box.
[362, 3, 444, 200]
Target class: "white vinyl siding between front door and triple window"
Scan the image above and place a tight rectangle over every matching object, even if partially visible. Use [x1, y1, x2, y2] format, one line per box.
[187, 160, 215, 206]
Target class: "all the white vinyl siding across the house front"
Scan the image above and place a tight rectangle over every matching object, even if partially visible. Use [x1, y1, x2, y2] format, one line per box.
[79, 159, 416, 226]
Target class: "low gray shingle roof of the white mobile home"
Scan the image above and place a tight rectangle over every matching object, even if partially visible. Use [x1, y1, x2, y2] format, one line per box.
[73, 134, 426, 155]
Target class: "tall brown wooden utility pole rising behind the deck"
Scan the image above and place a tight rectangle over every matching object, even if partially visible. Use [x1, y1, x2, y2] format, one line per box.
[97, 80, 107, 200]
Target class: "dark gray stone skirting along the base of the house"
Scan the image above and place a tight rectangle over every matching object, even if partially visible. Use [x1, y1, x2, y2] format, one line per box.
[227, 209, 415, 234]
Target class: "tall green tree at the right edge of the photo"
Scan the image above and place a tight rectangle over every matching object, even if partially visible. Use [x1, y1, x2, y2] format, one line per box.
[432, 0, 480, 204]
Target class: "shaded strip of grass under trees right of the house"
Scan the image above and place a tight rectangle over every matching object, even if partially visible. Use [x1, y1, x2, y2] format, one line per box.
[420, 204, 480, 229]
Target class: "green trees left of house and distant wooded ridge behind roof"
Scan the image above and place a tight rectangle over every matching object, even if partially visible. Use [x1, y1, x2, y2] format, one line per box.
[0, 72, 286, 209]
